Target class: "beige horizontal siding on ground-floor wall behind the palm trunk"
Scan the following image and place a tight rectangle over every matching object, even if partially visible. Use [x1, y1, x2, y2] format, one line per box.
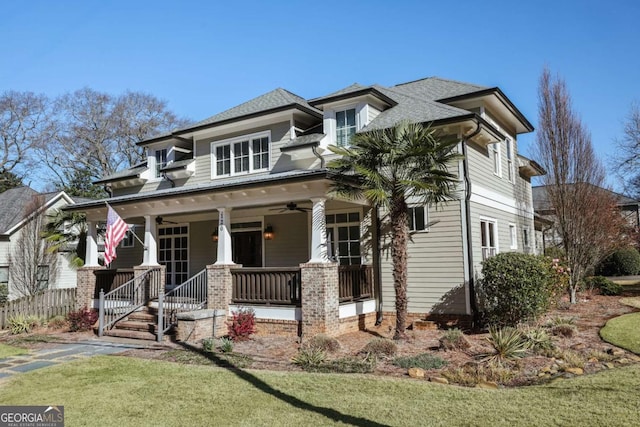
[381, 202, 466, 313]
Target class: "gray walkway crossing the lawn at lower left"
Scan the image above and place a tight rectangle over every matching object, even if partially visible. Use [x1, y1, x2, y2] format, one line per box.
[0, 339, 151, 381]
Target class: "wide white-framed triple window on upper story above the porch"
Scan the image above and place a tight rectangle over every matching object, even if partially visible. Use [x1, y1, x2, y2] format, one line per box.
[211, 132, 271, 177]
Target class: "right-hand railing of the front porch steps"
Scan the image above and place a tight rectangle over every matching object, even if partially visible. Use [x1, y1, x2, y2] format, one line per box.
[157, 268, 207, 341]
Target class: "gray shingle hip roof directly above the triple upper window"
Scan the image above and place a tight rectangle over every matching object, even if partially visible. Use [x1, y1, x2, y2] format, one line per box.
[184, 88, 322, 130]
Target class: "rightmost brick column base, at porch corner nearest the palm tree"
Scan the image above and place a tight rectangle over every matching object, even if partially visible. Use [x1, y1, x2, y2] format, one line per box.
[300, 263, 340, 338]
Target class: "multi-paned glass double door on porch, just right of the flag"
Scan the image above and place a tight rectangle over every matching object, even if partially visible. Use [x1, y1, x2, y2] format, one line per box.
[158, 225, 189, 288]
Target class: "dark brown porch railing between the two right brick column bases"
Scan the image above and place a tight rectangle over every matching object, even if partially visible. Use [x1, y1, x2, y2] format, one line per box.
[231, 267, 302, 305]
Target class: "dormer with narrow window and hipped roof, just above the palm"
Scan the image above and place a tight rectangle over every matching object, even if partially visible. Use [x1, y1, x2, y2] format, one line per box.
[309, 83, 397, 146]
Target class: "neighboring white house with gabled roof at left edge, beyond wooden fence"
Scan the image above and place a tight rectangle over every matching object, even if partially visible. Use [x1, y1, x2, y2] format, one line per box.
[0, 187, 86, 299]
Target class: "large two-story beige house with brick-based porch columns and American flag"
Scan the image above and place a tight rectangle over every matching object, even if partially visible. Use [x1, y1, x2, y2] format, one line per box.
[70, 77, 544, 342]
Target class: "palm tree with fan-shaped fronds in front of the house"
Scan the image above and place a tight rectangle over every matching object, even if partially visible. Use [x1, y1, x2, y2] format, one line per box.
[328, 122, 461, 339]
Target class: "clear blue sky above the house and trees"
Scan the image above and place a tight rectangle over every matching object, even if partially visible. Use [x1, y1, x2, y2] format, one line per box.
[0, 0, 640, 191]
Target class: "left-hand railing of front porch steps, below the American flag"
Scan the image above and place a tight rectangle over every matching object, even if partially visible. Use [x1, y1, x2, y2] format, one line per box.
[98, 268, 162, 336]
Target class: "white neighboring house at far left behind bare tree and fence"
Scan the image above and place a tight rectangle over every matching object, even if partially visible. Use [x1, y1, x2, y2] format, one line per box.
[0, 187, 86, 299]
